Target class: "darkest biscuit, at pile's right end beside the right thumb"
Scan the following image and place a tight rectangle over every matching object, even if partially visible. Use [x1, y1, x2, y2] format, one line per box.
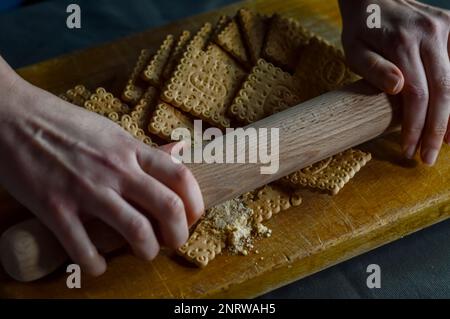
[295, 37, 357, 98]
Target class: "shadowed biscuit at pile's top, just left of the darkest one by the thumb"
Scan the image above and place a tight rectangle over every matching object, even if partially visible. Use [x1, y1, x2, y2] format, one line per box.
[263, 14, 311, 73]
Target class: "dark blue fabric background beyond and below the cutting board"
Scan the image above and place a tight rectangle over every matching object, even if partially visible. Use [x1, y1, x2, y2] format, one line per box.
[0, 0, 450, 298]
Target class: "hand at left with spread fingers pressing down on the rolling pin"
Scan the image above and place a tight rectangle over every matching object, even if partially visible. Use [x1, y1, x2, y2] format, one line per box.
[0, 61, 204, 275]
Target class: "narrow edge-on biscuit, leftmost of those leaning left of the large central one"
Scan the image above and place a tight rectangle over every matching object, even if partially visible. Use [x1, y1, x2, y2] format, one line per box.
[122, 49, 151, 105]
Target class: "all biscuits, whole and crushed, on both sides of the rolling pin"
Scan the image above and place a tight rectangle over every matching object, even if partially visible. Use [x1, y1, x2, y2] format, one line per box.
[61, 9, 371, 267]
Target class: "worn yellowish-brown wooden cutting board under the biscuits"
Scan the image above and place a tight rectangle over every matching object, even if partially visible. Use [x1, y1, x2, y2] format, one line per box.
[0, 0, 450, 298]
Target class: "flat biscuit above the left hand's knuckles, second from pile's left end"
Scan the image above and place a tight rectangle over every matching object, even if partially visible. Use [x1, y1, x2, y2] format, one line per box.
[83, 88, 129, 116]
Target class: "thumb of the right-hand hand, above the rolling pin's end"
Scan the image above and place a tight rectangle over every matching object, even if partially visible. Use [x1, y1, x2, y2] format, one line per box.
[346, 45, 405, 95]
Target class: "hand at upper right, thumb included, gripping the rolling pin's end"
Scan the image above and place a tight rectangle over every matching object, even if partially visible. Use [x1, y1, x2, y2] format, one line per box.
[340, 0, 450, 165]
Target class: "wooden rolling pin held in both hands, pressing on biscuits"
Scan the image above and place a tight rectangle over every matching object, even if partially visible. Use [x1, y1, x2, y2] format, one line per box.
[0, 81, 396, 282]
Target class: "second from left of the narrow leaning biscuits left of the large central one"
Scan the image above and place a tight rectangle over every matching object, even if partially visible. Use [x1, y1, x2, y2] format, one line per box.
[142, 34, 175, 87]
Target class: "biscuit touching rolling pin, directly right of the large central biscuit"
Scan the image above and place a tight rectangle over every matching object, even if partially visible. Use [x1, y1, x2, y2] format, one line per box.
[230, 59, 308, 124]
